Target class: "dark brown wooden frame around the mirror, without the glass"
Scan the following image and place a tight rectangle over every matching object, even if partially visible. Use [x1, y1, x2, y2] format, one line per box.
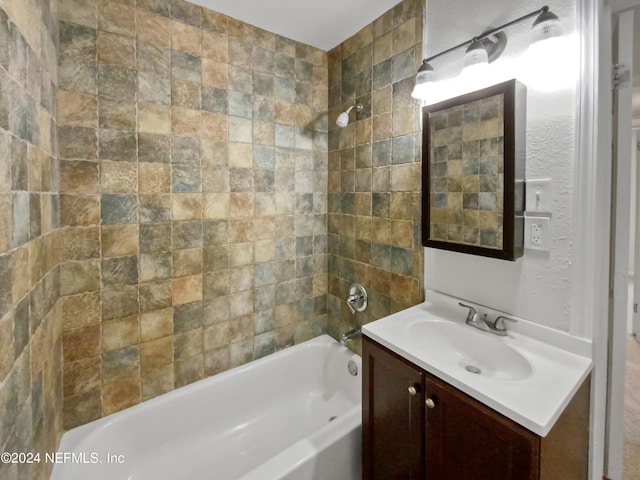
[422, 79, 526, 261]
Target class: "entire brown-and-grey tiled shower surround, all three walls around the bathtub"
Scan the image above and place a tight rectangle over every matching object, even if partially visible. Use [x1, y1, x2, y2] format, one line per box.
[0, 0, 423, 458]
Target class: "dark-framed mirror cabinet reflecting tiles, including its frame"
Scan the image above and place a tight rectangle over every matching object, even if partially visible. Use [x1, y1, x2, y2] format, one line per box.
[422, 80, 526, 260]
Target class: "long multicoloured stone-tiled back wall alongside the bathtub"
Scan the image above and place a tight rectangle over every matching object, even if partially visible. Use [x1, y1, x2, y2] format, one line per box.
[58, 0, 327, 428]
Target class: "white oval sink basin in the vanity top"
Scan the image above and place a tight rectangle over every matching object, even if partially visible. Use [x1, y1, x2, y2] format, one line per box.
[407, 320, 532, 380]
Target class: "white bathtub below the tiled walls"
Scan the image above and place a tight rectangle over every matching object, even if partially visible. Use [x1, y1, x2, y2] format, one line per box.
[51, 335, 361, 480]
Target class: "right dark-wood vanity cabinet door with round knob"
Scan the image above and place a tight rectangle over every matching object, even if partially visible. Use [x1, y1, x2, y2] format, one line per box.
[426, 374, 540, 480]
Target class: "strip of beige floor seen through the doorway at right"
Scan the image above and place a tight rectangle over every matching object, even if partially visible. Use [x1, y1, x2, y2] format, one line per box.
[622, 337, 640, 480]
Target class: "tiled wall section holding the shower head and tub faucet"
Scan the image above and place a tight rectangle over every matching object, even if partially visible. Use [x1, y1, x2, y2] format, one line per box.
[328, 0, 423, 348]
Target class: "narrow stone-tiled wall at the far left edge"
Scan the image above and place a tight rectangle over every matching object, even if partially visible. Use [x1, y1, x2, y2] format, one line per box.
[0, 0, 62, 479]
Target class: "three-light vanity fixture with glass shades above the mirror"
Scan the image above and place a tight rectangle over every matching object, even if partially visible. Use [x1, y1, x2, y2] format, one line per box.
[411, 5, 562, 100]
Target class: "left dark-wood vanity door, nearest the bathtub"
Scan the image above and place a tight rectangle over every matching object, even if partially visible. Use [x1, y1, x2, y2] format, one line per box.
[362, 337, 425, 480]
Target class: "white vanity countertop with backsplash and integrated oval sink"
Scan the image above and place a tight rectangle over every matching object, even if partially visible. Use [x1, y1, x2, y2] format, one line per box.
[362, 291, 592, 436]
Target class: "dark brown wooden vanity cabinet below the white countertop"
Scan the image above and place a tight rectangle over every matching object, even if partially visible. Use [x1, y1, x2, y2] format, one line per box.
[362, 336, 589, 480]
